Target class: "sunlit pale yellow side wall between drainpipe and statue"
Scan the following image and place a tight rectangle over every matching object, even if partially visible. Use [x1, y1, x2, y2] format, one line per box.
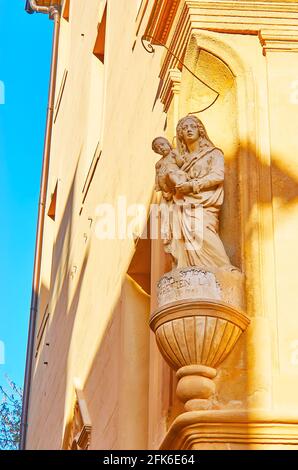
[27, 0, 165, 449]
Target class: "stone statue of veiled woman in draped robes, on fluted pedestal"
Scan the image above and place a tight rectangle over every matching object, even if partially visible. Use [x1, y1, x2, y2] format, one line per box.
[153, 115, 236, 271]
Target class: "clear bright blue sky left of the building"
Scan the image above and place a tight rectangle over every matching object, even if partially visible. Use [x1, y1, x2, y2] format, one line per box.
[0, 0, 53, 386]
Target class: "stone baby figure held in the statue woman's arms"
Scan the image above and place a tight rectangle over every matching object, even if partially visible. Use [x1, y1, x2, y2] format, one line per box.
[152, 137, 187, 199]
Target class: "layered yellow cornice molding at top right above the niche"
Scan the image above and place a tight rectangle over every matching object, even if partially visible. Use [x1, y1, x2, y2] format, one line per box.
[144, 0, 298, 110]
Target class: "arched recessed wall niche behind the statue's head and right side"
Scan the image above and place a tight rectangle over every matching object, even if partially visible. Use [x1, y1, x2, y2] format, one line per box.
[175, 30, 255, 271]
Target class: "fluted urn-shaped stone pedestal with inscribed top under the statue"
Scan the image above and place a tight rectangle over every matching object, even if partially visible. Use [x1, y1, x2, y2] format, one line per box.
[150, 266, 250, 411]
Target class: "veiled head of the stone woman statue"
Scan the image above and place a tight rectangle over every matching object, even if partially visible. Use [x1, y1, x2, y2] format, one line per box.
[176, 114, 214, 153]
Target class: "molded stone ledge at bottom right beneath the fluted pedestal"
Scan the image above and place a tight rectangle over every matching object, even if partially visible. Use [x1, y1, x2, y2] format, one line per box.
[160, 410, 298, 450]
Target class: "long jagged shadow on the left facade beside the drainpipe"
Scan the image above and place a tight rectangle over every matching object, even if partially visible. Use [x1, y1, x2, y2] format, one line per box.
[27, 164, 89, 449]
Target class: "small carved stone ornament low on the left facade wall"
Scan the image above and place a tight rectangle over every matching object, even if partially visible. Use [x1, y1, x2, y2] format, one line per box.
[68, 390, 92, 450]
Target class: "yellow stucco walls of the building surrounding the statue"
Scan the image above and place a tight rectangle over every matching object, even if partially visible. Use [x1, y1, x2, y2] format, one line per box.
[27, 0, 298, 449]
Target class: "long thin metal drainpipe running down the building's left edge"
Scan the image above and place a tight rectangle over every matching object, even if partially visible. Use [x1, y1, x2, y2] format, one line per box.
[20, 0, 60, 450]
